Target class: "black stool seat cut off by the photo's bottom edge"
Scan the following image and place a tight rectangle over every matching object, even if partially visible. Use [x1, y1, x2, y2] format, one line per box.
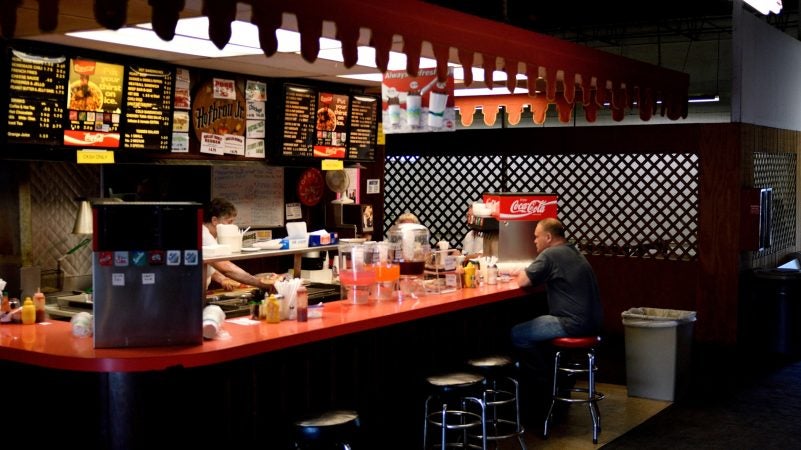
[294, 410, 359, 450]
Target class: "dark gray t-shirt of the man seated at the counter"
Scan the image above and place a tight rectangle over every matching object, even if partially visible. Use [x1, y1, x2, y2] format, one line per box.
[526, 244, 603, 336]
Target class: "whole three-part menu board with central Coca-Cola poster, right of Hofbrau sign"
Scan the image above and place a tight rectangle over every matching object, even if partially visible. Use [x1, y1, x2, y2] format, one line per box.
[281, 85, 379, 161]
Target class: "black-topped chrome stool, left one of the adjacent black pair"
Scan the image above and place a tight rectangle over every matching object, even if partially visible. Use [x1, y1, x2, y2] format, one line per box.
[423, 372, 487, 450]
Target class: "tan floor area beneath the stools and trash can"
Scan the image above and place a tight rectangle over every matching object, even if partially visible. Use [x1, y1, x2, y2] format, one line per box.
[498, 383, 671, 450]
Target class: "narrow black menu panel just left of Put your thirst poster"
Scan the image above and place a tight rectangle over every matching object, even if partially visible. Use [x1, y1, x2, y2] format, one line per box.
[283, 86, 316, 157]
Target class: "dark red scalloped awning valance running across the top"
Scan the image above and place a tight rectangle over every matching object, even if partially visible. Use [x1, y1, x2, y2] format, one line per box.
[0, 0, 689, 121]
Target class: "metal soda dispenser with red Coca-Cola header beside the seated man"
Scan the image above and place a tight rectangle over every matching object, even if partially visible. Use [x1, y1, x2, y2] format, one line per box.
[483, 192, 559, 265]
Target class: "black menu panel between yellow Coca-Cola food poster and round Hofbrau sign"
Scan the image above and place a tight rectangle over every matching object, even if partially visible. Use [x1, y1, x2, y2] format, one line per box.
[123, 66, 174, 150]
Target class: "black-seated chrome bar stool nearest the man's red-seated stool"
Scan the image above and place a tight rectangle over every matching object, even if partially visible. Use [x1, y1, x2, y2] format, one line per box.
[467, 355, 526, 450]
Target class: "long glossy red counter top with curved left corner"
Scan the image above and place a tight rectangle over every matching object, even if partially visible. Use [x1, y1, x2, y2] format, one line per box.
[0, 282, 527, 372]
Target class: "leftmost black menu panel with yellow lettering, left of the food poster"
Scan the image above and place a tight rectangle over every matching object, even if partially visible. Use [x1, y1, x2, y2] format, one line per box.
[8, 50, 67, 145]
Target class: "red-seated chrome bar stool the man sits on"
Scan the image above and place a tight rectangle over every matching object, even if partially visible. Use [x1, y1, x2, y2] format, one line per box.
[543, 336, 604, 444]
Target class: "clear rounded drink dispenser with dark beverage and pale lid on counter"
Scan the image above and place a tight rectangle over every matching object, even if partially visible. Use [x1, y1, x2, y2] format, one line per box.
[387, 223, 431, 296]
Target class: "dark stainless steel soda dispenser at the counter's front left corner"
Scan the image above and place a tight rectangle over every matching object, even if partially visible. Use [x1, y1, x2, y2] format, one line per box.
[92, 202, 204, 348]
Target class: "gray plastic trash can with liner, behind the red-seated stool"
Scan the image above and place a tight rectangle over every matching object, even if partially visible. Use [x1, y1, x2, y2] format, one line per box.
[621, 307, 695, 402]
